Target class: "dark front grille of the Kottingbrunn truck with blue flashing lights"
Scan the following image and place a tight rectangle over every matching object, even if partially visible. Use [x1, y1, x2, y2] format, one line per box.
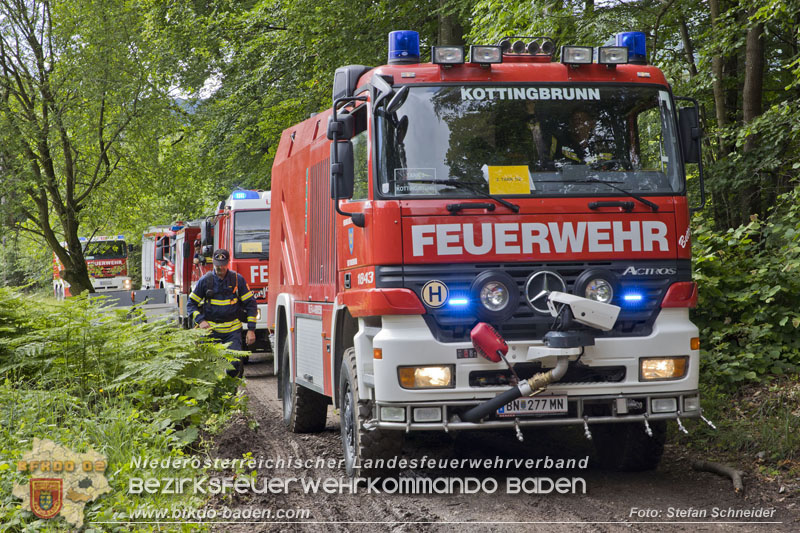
[376, 260, 691, 342]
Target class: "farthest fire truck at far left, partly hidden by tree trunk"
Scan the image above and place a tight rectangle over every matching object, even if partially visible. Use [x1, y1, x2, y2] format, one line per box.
[53, 235, 131, 299]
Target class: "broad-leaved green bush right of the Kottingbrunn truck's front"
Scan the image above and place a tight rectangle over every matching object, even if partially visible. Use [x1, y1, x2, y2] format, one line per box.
[694, 190, 800, 385]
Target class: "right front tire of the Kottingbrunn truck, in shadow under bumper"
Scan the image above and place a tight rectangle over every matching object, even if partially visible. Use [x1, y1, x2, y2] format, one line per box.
[592, 420, 667, 472]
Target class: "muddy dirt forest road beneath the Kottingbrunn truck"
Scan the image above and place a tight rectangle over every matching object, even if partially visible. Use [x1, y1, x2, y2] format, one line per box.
[212, 360, 800, 532]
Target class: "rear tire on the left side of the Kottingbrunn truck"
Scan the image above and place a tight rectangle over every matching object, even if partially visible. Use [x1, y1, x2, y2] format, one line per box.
[279, 339, 328, 433]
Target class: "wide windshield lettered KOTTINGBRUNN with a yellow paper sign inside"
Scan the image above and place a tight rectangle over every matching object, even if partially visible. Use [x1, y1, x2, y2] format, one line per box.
[376, 84, 684, 197]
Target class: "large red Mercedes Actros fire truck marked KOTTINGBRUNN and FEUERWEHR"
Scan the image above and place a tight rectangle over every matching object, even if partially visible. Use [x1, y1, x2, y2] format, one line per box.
[268, 32, 704, 475]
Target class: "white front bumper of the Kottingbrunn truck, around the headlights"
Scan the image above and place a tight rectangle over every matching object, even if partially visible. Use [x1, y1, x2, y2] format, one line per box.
[355, 309, 700, 431]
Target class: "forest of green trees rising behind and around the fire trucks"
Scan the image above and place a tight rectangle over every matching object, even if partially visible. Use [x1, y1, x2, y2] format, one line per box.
[0, 0, 800, 471]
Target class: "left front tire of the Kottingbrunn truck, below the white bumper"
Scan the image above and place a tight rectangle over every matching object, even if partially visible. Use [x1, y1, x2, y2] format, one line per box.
[339, 348, 405, 477]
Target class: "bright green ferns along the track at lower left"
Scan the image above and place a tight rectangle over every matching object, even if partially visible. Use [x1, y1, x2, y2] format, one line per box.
[0, 288, 241, 531]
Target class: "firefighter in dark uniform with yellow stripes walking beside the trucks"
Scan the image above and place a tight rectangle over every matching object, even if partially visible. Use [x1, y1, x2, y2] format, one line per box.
[188, 249, 258, 377]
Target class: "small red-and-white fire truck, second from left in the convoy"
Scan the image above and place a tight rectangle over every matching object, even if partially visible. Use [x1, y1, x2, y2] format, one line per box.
[142, 223, 182, 303]
